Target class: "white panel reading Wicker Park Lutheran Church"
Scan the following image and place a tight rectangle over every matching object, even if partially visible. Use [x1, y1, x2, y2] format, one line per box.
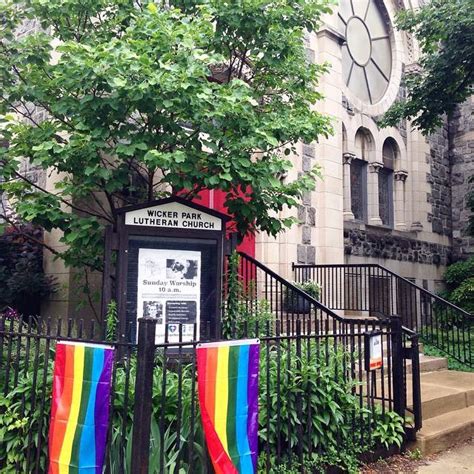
[125, 202, 222, 230]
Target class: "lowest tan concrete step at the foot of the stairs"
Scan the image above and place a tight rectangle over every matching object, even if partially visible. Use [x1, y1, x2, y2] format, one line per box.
[409, 406, 474, 455]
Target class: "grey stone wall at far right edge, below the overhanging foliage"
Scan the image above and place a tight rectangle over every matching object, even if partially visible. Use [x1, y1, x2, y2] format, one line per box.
[449, 97, 474, 259]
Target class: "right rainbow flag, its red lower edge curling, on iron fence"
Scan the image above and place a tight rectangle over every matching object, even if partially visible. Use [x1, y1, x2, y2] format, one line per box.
[196, 339, 259, 474]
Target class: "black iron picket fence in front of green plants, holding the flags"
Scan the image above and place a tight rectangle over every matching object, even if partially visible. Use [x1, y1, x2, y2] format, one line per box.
[0, 312, 414, 473]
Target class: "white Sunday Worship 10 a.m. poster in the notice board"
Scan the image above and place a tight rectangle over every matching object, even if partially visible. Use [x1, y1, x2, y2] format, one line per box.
[137, 248, 201, 344]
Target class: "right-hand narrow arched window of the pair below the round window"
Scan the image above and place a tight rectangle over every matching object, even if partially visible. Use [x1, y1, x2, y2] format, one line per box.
[379, 138, 399, 227]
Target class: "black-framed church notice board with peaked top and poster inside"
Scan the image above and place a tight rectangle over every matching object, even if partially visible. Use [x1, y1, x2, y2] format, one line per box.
[111, 197, 230, 344]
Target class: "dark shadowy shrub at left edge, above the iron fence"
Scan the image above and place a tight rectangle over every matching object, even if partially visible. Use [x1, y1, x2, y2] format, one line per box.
[0, 224, 55, 315]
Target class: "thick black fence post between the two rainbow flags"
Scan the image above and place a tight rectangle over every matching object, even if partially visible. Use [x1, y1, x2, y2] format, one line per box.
[131, 318, 156, 474]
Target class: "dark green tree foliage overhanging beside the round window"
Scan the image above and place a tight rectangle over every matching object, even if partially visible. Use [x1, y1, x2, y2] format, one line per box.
[382, 0, 474, 133]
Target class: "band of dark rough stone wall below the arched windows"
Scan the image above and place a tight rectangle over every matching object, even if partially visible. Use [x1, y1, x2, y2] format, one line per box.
[344, 228, 452, 265]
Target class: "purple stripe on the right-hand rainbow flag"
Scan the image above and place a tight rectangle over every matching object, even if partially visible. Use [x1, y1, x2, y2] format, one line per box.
[247, 344, 260, 472]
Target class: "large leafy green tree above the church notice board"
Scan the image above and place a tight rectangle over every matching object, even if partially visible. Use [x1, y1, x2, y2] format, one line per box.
[0, 0, 331, 269]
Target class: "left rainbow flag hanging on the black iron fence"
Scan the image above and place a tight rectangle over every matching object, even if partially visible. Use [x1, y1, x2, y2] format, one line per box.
[48, 342, 114, 474]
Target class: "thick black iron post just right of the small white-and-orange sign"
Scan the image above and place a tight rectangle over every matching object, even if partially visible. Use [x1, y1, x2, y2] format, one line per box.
[390, 316, 406, 419]
